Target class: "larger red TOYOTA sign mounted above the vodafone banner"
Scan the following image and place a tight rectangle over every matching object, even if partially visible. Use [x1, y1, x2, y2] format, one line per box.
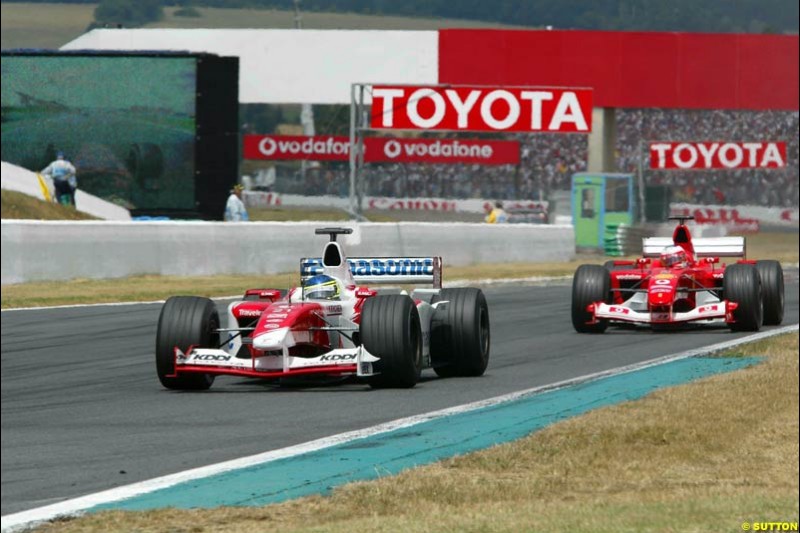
[371, 85, 592, 133]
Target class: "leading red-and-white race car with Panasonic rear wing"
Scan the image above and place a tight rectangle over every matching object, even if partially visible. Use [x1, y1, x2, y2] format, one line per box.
[156, 228, 490, 390]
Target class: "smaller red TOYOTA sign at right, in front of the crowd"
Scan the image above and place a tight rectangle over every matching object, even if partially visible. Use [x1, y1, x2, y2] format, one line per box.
[650, 141, 786, 170]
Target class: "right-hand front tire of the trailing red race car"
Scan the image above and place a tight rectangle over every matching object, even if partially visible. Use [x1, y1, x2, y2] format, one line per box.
[722, 263, 764, 331]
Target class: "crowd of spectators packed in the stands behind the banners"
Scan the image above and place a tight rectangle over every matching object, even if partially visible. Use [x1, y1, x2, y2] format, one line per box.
[280, 109, 798, 207]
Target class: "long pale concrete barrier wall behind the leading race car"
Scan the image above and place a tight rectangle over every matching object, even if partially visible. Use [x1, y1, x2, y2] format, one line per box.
[1, 220, 575, 284]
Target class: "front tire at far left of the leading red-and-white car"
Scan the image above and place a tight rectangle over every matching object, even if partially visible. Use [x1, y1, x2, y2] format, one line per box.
[156, 296, 219, 390]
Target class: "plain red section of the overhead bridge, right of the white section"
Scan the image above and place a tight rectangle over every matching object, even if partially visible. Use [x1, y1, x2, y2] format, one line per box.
[438, 30, 800, 111]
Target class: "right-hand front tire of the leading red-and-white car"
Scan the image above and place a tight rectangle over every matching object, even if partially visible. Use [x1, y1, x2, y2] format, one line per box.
[359, 294, 422, 389]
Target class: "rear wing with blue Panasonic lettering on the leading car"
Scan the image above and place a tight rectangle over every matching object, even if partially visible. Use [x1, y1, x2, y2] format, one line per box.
[300, 257, 442, 289]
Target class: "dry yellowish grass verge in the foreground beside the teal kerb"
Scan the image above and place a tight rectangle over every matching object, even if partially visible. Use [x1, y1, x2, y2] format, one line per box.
[37, 333, 800, 533]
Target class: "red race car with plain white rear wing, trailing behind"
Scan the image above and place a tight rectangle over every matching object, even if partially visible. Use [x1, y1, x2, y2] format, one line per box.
[572, 216, 784, 333]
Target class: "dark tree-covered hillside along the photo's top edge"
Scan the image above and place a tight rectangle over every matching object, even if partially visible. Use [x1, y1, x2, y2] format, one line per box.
[4, 0, 800, 33]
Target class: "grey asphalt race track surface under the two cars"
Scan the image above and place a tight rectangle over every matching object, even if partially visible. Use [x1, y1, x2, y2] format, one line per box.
[0, 278, 798, 515]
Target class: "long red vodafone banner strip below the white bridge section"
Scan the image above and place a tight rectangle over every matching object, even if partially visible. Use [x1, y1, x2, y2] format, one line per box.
[244, 135, 519, 165]
